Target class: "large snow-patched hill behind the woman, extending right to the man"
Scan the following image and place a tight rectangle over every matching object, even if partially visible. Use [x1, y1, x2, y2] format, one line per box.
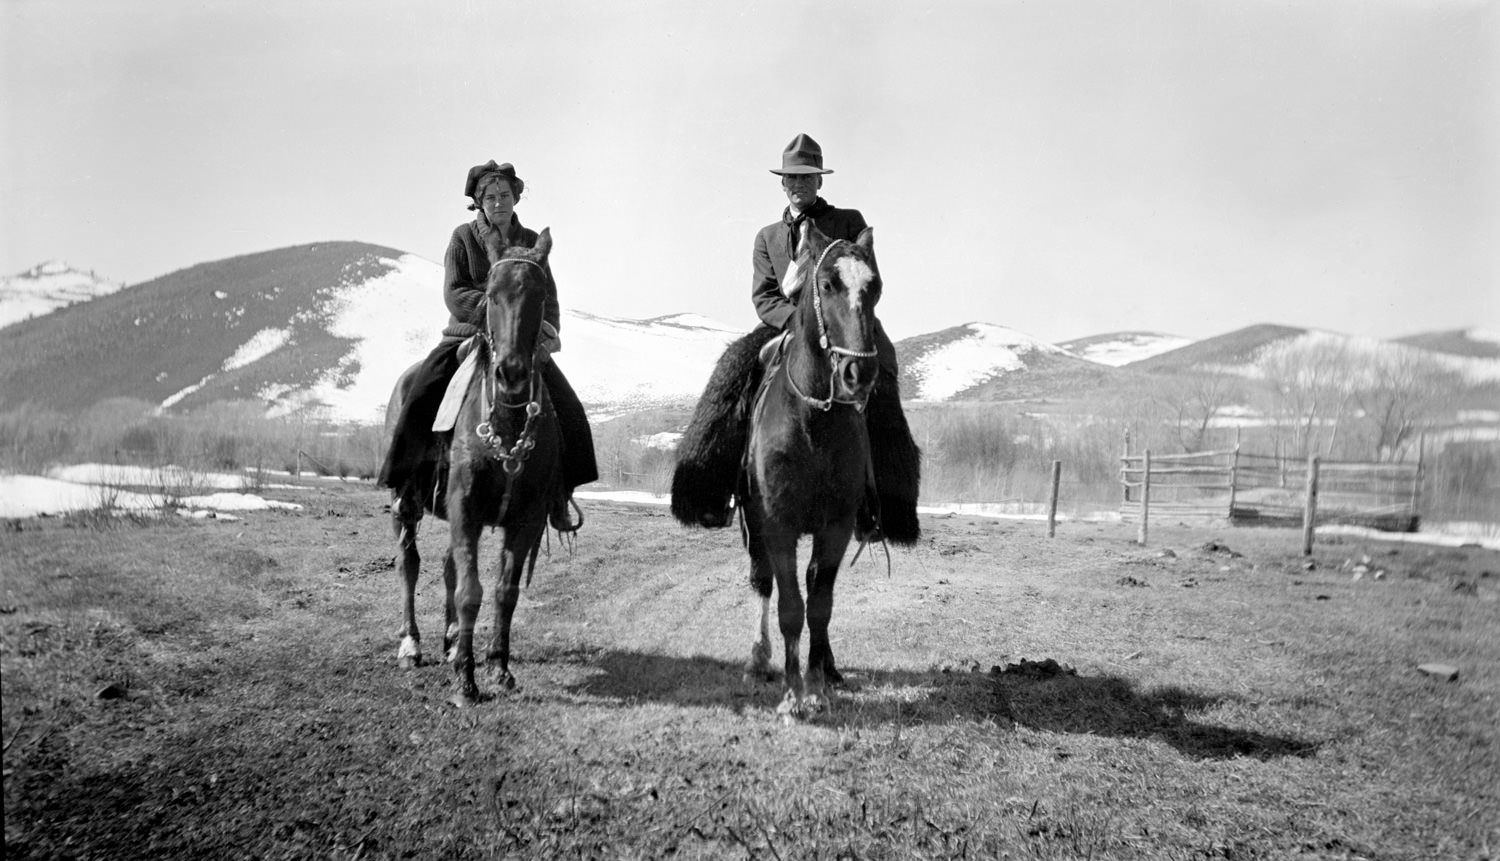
[0, 243, 741, 423]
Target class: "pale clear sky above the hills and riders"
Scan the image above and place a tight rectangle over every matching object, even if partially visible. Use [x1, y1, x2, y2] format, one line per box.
[0, 0, 1500, 341]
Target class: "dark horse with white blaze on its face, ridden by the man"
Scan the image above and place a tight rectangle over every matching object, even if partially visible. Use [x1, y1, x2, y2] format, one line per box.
[741, 224, 881, 717]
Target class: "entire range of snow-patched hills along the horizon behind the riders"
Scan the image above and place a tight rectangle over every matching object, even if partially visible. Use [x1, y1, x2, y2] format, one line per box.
[0, 242, 1500, 422]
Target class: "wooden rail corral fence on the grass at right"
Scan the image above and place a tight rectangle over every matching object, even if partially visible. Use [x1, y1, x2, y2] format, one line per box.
[1121, 437, 1422, 543]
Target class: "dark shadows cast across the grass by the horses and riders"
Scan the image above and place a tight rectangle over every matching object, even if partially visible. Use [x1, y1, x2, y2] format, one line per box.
[569, 650, 1319, 759]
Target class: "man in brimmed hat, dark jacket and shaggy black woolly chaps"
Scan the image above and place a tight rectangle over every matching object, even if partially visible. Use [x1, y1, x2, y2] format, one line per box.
[672, 135, 921, 545]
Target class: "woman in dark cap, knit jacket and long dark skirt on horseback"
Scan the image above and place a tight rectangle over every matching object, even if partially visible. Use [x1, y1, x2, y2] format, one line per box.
[380, 159, 599, 531]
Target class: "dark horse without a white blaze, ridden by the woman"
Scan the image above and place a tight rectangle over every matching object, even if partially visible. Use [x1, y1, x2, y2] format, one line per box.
[386, 230, 563, 707]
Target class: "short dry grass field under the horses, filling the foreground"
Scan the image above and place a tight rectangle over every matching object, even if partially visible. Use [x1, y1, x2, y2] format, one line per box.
[0, 485, 1500, 861]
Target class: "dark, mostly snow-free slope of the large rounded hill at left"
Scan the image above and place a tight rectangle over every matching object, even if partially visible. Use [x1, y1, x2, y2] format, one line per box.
[0, 242, 417, 423]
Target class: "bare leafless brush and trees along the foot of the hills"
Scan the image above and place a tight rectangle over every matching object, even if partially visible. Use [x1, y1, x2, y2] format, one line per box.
[0, 393, 1500, 522]
